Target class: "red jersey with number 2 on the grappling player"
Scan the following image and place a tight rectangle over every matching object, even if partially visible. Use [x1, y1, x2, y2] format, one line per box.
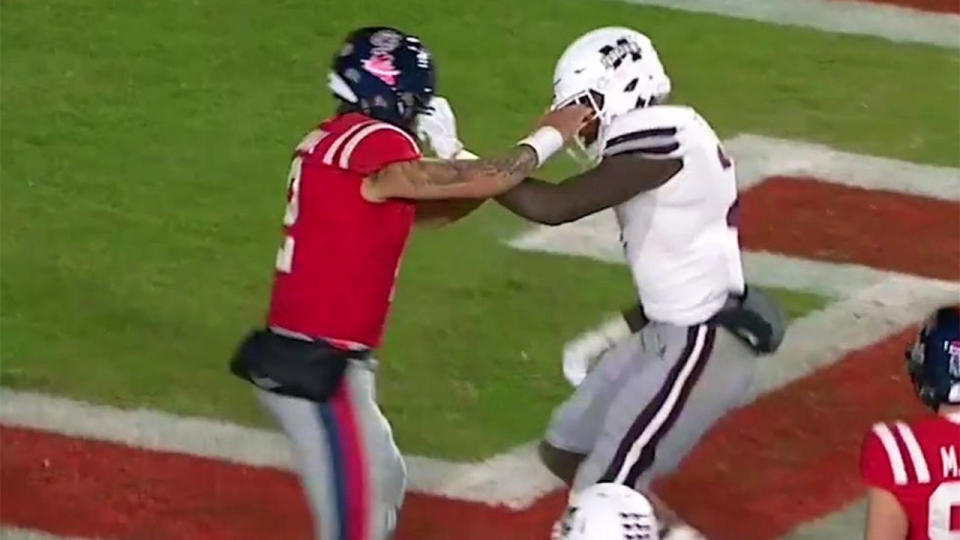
[268, 113, 421, 348]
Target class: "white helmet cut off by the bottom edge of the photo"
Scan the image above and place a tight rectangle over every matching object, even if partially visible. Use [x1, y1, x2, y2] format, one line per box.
[551, 484, 660, 540]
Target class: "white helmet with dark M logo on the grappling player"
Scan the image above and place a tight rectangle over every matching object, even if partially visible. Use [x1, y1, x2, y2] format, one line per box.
[551, 26, 670, 163]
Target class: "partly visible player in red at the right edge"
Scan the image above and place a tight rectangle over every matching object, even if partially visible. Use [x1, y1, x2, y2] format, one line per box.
[860, 307, 960, 540]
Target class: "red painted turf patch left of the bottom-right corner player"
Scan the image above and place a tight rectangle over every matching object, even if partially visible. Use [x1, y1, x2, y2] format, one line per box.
[657, 329, 929, 540]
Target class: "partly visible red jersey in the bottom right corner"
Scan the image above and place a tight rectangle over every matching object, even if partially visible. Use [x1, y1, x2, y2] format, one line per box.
[860, 416, 960, 540]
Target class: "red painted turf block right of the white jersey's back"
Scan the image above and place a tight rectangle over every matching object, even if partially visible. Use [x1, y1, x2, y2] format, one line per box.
[741, 176, 960, 280]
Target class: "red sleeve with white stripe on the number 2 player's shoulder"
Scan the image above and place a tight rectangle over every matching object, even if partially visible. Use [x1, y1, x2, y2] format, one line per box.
[338, 122, 422, 175]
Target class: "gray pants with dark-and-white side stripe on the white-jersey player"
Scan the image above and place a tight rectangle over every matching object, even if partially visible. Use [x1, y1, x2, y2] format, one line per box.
[546, 322, 757, 491]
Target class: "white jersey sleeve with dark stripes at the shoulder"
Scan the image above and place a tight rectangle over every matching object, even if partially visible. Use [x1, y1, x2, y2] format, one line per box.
[603, 105, 696, 159]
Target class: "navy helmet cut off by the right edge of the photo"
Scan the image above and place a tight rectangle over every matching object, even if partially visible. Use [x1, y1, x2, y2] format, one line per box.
[907, 306, 960, 410]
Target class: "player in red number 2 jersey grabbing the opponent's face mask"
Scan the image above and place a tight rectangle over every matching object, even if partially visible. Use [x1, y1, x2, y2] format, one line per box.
[231, 27, 592, 540]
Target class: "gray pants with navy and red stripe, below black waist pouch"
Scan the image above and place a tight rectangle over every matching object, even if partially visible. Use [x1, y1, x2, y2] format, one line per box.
[256, 360, 406, 540]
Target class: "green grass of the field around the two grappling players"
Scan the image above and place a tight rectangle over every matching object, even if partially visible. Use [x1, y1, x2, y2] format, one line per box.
[0, 0, 960, 458]
